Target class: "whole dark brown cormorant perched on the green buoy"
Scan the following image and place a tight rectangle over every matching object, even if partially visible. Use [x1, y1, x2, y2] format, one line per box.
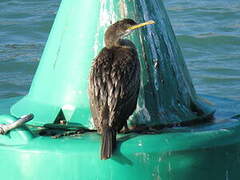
[89, 19, 155, 159]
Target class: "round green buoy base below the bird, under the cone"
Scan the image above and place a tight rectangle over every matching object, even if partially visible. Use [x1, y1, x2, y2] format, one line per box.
[0, 107, 240, 180]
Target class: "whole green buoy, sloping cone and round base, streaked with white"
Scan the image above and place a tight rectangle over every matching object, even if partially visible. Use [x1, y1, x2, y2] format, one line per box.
[0, 0, 237, 180]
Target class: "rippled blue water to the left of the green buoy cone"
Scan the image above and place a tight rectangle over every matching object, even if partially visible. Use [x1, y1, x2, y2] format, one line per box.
[0, 0, 60, 99]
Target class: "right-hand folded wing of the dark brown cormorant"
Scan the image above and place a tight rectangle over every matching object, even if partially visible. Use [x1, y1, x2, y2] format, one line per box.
[107, 49, 140, 127]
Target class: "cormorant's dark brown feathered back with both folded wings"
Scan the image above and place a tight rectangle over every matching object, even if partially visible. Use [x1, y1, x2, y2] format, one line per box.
[89, 48, 140, 129]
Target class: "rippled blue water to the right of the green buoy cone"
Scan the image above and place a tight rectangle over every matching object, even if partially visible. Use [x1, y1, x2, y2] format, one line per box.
[164, 0, 240, 100]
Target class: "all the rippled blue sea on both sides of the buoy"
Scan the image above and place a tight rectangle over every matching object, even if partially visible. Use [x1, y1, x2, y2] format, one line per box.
[0, 0, 240, 100]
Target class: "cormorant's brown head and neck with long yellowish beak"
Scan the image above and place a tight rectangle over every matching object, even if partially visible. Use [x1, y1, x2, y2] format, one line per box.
[105, 19, 155, 47]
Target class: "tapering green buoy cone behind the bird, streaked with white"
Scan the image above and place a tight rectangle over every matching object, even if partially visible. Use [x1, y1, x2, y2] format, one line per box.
[11, 0, 213, 127]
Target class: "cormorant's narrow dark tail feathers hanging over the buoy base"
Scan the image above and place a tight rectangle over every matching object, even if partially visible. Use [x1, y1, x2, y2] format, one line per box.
[101, 127, 116, 160]
